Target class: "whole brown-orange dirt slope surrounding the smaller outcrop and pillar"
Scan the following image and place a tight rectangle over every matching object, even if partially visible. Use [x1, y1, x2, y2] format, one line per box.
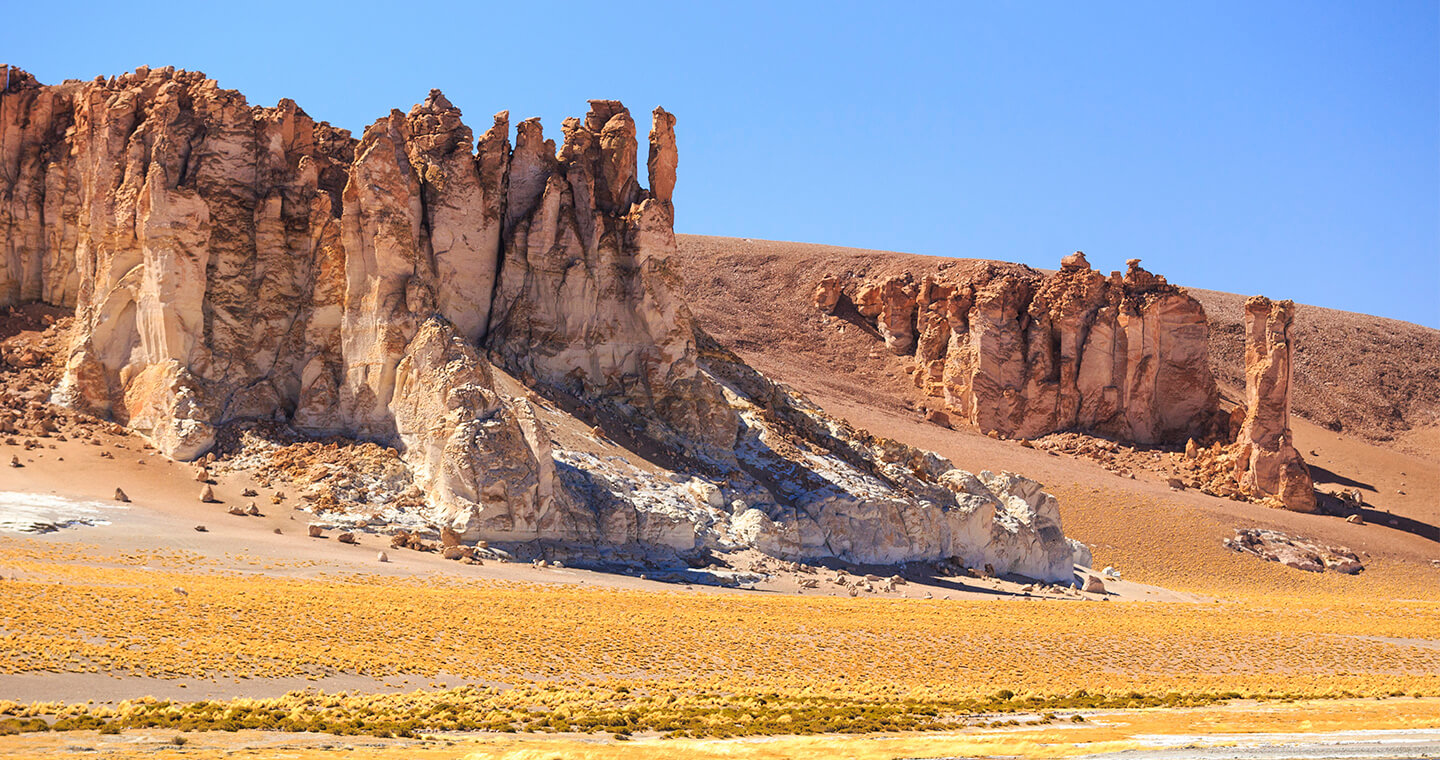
[677, 236, 1440, 596]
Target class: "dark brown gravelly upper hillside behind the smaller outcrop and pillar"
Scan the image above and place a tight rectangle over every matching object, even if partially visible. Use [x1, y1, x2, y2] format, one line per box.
[678, 235, 1440, 455]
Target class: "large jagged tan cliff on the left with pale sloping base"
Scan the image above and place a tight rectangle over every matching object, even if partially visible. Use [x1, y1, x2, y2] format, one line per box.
[0, 68, 1073, 580]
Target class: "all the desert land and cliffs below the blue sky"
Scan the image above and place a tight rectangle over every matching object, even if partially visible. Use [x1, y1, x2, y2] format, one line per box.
[0, 66, 1440, 759]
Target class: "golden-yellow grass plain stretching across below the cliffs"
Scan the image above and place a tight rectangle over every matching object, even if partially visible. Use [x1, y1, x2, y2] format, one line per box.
[0, 538, 1440, 737]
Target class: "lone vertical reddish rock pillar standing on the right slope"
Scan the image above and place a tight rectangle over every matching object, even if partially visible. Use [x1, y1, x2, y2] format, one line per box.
[1236, 295, 1316, 512]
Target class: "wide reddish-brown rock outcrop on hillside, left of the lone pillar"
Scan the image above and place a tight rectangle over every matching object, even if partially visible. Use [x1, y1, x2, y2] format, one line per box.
[815, 252, 1218, 443]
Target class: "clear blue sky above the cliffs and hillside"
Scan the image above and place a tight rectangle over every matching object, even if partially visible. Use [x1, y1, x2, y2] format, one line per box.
[0, 0, 1440, 327]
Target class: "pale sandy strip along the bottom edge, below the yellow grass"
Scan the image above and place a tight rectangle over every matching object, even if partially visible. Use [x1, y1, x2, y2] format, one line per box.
[0, 698, 1440, 760]
